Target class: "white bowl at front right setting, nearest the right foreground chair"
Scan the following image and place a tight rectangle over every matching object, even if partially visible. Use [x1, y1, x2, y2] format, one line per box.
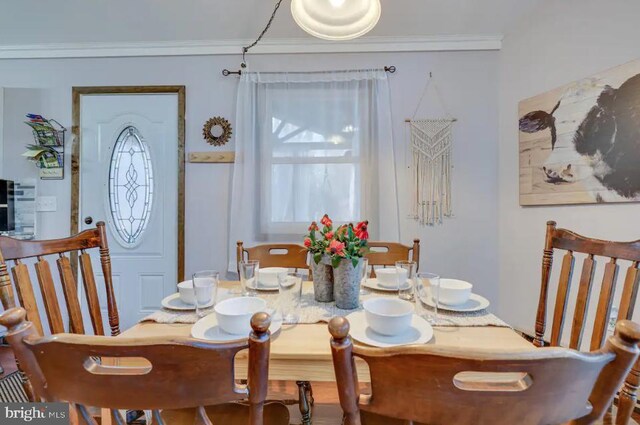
[362, 298, 413, 335]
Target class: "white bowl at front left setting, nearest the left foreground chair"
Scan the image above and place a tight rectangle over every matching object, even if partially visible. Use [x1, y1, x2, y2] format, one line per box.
[214, 297, 267, 336]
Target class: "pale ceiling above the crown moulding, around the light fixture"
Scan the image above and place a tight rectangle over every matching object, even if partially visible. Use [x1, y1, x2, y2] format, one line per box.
[0, 0, 540, 46]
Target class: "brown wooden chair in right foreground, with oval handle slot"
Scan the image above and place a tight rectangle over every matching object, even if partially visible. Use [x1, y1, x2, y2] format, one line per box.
[329, 317, 640, 425]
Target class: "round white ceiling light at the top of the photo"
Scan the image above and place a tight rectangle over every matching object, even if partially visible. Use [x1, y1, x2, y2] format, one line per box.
[291, 0, 382, 40]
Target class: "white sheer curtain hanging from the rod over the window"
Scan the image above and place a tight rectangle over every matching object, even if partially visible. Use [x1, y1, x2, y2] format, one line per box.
[229, 70, 399, 271]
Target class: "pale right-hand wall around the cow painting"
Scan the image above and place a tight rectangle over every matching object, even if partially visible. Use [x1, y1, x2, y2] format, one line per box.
[499, 0, 640, 330]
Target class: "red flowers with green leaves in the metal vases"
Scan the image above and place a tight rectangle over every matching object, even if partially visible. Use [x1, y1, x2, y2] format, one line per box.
[304, 214, 369, 267]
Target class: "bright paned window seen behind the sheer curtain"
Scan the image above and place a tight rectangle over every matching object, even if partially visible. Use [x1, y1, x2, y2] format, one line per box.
[260, 87, 363, 235]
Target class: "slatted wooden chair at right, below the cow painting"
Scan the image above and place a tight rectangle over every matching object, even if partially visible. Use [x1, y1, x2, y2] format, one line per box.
[533, 221, 640, 417]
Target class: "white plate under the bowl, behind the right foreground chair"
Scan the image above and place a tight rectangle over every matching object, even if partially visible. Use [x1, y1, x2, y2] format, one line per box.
[347, 311, 433, 348]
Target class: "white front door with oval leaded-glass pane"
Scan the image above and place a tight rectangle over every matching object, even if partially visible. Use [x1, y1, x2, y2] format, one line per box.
[80, 93, 179, 329]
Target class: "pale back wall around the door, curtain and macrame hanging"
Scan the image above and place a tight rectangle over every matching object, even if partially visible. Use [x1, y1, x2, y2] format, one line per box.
[0, 52, 498, 300]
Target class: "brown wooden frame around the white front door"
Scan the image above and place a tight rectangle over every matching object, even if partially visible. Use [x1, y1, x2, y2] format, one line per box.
[71, 86, 186, 282]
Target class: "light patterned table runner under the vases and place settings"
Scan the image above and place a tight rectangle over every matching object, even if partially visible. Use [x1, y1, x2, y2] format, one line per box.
[141, 285, 509, 327]
